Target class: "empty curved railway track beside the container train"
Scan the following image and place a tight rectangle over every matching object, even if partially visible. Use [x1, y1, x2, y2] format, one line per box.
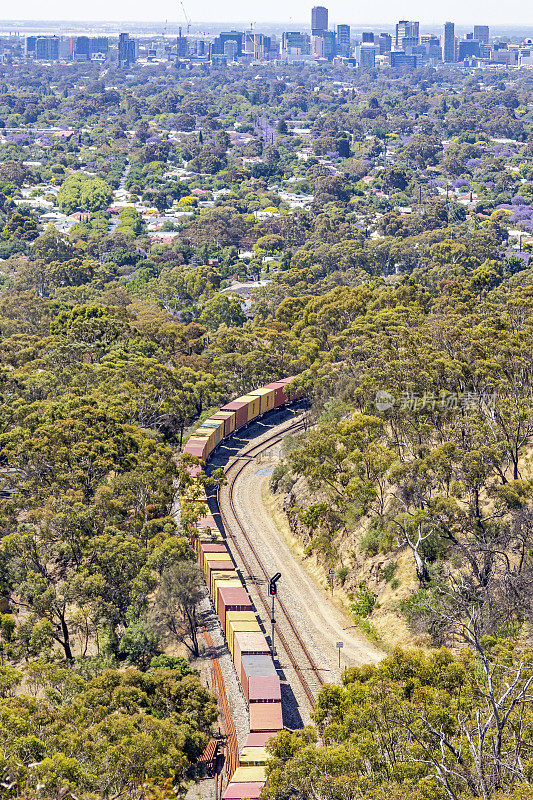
[213, 420, 324, 710]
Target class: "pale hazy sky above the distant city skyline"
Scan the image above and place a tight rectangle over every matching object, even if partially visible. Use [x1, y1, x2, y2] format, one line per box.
[0, 0, 533, 26]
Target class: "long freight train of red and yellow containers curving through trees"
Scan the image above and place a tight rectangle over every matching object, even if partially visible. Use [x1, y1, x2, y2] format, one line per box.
[183, 377, 302, 800]
